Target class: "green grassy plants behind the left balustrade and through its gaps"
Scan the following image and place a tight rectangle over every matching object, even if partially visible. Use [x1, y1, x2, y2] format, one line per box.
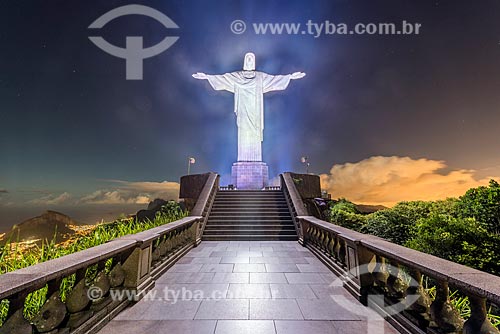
[0, 201, 187, 326]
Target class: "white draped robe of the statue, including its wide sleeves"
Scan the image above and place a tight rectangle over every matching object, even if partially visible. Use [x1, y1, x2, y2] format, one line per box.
[207, 71, 290, 161]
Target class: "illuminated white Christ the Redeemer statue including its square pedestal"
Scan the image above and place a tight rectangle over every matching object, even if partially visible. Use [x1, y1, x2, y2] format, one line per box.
[193, 53, 305, 189]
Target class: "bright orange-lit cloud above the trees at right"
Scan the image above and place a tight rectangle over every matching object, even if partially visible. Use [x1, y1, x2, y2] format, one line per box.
[320, 156, 498, 206]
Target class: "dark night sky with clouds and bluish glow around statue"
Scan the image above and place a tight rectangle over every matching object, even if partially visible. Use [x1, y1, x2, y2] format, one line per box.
[0, 0, 500, 227]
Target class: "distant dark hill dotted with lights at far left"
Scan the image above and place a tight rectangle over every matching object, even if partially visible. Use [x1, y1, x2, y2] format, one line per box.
[0, 211, 80, 244]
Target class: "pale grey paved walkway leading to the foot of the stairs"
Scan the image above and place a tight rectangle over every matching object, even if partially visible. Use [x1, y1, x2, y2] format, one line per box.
[100, 241, 397, 334]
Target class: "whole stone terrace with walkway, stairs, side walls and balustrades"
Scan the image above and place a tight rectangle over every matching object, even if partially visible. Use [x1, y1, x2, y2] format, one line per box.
[0, 173, 500, 334]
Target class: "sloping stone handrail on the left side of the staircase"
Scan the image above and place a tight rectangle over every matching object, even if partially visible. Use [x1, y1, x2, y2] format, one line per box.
[191, 173, 220, 245]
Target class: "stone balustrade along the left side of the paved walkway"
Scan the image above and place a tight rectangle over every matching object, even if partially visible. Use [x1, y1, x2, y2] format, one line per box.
[0, 216, 202, 333]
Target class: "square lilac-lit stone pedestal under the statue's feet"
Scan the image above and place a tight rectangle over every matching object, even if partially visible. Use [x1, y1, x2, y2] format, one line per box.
[231, 161, 269, 190]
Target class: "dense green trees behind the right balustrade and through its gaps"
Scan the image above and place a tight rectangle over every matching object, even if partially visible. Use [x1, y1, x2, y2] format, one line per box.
[328, 180, 500, 327]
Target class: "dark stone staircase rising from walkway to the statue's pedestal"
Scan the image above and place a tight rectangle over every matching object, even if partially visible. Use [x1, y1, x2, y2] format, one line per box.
[203, 190, 297, 240]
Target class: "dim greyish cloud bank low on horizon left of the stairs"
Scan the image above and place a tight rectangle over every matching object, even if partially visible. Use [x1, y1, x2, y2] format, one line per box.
[79, 180, 179, 204]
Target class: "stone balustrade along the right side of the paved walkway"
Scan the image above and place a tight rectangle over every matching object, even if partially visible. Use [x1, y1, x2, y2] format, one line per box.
[298, 216, 500, 334]
